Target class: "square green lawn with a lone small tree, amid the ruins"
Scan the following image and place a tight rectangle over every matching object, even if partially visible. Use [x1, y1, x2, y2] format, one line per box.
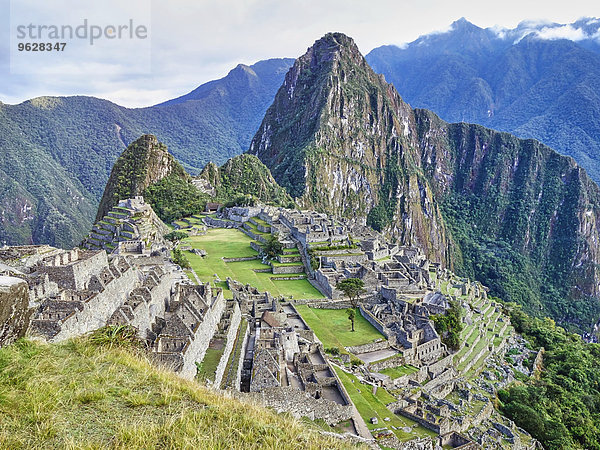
[296, 305, 384, 348]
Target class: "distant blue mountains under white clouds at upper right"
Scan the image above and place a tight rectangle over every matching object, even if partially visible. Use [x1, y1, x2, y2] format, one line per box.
[366, 18, 600, 181]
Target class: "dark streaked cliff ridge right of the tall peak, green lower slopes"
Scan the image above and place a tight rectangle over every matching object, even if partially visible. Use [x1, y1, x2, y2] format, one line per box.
[415, 110, 600, 329]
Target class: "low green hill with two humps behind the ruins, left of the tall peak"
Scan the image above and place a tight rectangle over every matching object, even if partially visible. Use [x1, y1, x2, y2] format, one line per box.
[95, 134, 294, 229]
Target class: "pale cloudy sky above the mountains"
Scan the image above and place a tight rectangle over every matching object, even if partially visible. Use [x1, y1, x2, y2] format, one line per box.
[0, 0, 598, 107]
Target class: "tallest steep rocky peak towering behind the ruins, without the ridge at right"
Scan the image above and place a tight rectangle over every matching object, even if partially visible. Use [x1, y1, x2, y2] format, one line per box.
[249, 33, 447, 262]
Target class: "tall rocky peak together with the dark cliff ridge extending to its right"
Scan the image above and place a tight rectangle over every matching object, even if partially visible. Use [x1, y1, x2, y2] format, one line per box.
[249, 34, 600, 330]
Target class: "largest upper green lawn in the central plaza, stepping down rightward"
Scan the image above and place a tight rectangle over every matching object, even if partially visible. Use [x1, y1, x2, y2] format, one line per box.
[183, 228, 323, 299]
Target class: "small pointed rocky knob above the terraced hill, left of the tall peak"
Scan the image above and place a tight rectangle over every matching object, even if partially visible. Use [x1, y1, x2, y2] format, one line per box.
[96, 134, 191, 222]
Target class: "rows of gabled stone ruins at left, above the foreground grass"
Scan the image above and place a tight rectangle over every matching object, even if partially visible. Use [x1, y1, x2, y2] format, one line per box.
[0, 246, 226, 378]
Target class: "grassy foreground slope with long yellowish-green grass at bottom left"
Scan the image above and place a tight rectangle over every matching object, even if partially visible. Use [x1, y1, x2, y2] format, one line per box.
[0, 339, 354, 449]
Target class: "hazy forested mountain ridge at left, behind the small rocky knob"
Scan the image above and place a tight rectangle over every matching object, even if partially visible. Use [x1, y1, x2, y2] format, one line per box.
[0, 59, 293, 247]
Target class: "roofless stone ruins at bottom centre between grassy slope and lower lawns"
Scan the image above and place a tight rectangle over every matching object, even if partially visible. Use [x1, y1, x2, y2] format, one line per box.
[228, 279, 369, 436]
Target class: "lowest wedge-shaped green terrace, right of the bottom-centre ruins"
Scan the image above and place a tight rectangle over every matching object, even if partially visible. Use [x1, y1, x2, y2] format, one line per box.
[334, 366, 437, 441]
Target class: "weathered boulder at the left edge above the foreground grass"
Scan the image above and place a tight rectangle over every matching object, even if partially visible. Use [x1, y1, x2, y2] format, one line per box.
[0, 276, 30, 347]
